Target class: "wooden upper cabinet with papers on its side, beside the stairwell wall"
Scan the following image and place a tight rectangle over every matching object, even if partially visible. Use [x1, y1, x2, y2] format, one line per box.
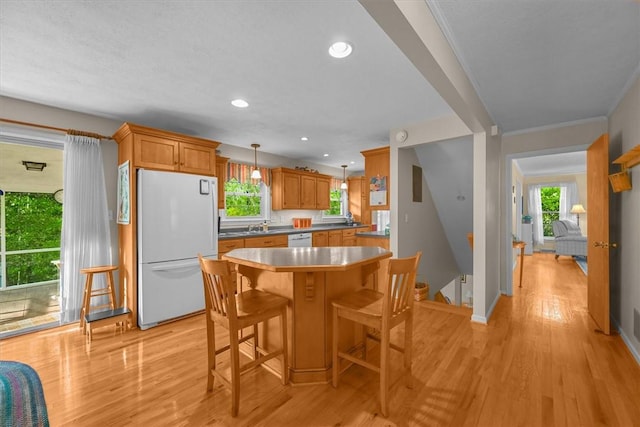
[361, 147, 391, 210]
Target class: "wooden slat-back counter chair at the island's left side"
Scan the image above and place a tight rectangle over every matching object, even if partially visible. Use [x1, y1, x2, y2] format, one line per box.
[199, 255, 289, 417]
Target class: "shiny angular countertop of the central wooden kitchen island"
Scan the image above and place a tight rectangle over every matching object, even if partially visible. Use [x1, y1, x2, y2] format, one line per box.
[222, 246, 392, 272]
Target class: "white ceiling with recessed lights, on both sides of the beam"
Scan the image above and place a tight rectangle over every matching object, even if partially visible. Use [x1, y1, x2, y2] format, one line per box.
[0, 0, 640, 176]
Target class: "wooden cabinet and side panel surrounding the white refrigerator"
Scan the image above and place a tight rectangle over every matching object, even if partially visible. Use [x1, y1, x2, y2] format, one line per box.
[113, 123, 220, 326]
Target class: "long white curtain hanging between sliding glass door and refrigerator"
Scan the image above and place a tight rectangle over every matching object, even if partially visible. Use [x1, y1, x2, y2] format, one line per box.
[60, 135, 112, 323]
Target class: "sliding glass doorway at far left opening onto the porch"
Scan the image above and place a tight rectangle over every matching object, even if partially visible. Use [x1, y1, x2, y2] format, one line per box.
[0, 138, 63, 338]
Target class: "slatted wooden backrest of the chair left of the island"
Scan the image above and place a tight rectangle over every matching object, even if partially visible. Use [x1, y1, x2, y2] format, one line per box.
[198, 255, 238, 325]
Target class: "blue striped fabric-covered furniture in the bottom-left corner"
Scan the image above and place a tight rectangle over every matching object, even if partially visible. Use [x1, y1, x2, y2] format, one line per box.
[0, 360, 49, 427]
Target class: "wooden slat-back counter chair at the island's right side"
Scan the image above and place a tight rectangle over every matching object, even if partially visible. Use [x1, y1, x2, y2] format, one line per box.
[332, 252, 422, 416]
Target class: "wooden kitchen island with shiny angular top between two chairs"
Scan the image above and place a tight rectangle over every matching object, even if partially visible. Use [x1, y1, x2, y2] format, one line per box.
[223, 246, 391, 384]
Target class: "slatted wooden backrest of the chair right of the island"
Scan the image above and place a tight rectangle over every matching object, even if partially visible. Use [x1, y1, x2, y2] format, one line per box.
[382, 251, 422, 322]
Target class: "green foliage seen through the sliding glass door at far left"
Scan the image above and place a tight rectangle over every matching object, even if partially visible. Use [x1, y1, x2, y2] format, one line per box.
[4, 192, 62, 287]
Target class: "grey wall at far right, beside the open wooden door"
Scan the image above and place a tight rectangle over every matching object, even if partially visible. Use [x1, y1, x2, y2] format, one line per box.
[609, 73, 640, 363]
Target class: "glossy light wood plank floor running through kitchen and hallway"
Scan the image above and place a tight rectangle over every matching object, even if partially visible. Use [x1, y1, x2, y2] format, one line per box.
[0, 254, 640, 426]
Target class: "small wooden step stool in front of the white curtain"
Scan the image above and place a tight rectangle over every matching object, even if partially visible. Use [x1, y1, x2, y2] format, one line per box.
[80, 265, 131, 342]
